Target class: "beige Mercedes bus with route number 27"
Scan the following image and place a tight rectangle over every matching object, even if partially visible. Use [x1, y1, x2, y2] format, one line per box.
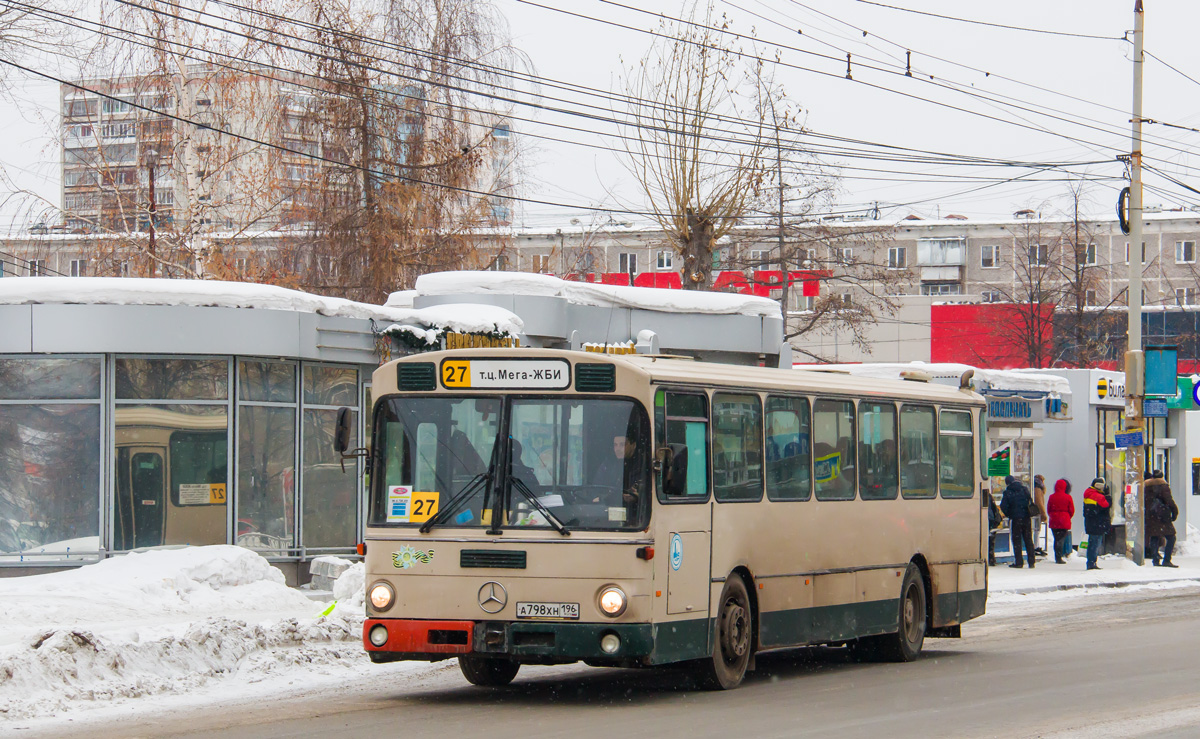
[350, 349, 988, 689]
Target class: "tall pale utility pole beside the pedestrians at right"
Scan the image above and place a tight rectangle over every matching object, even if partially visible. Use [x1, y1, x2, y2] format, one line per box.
[1124, 0, 1146, 565]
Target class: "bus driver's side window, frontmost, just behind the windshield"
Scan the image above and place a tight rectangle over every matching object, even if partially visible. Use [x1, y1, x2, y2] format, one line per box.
[654, 390, 708, 503]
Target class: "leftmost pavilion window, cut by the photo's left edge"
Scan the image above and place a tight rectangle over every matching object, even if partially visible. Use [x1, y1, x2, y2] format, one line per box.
[0, 358, 101, 554]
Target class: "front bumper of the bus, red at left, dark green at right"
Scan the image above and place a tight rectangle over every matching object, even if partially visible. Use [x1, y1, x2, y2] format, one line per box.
[362, 619, 654, 663]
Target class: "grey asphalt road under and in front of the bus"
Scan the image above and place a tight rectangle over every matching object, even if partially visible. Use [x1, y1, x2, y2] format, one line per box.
[32, 589, 1200, 739]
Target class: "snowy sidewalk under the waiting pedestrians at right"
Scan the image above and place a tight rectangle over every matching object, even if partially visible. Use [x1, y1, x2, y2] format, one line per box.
[988, 552, 1200, 595]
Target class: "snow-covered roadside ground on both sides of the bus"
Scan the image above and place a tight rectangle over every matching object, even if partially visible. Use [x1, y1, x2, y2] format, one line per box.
[0, 539, 1200, 734]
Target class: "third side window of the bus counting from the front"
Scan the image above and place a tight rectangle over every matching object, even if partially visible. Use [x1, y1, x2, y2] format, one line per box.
[766, 397, 812, 500]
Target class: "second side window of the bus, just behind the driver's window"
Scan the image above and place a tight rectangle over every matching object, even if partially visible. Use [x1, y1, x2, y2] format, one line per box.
[713, 392, 762, 503]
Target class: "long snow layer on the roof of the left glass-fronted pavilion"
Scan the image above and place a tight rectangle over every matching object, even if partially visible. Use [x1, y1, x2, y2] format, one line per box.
[0, 277, 524, 334]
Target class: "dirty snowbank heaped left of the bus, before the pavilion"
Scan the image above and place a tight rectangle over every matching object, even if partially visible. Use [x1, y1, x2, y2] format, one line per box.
[0, 546, 365, 719]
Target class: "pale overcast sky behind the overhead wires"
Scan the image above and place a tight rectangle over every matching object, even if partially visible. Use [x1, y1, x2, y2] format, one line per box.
[0, 0, 1200, 228]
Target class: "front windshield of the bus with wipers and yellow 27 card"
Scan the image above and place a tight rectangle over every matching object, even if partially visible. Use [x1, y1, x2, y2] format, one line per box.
[370, 396, 650, 530]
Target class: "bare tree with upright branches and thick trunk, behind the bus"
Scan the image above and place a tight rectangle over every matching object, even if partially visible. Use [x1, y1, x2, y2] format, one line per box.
[623, 2, 772, 289]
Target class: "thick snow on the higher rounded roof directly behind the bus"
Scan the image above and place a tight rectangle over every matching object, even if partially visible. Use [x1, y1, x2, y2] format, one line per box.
[403, 271, 782, 318]
